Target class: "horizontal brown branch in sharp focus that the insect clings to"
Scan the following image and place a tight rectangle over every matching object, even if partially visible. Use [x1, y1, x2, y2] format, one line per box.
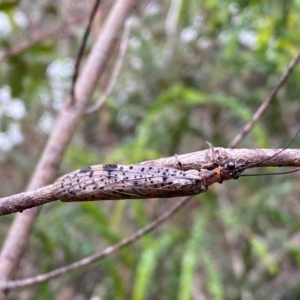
[0, 147, 300, 216]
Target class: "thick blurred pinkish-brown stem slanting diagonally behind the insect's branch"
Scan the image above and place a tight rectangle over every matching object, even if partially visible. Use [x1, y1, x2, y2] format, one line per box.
[0, 0, 136, 299]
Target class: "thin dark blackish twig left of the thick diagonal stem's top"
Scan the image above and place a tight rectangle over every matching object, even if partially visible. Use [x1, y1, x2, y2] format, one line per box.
[70, 0, 101, 104]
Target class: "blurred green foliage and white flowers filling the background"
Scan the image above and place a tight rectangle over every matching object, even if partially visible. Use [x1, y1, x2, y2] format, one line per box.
[0, 0, 300, 300]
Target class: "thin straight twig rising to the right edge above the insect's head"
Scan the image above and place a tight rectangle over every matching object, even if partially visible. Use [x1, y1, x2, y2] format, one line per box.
[228, 51, 300, 148]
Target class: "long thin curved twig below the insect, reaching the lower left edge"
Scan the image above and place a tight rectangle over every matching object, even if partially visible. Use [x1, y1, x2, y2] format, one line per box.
[0, 196, 193, 290]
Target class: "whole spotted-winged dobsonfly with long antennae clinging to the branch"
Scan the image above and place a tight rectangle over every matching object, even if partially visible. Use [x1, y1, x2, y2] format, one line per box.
[53, 130, 300, 202]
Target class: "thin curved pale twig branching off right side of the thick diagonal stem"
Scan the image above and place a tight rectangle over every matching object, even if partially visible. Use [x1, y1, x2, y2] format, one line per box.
[86, 20, 130, 115]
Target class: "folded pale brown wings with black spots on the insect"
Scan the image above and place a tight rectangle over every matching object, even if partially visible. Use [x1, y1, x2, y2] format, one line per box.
[53, 164, 215, 202]
